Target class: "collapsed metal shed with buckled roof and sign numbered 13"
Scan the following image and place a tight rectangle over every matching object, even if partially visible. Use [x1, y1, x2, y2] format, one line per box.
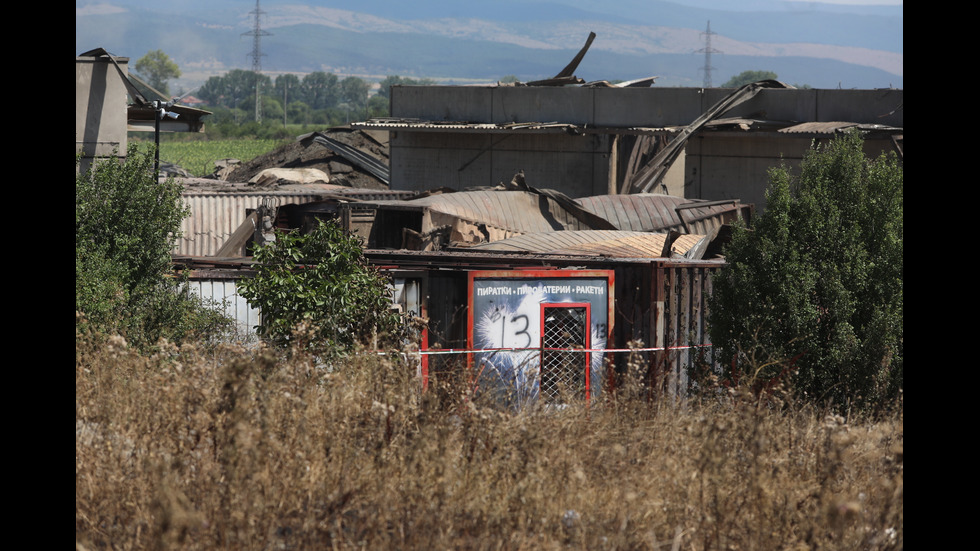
[183, 186, 752, 407]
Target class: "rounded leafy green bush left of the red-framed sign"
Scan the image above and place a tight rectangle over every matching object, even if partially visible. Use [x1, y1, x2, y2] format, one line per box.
[239, 222, 400, 357]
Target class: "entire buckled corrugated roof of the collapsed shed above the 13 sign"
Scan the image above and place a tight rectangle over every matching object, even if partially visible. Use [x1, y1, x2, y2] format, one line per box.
[258, 187, 752, 258]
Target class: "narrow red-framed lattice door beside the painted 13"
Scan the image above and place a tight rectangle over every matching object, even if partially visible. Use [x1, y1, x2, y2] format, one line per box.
[540, 304, 589, 404]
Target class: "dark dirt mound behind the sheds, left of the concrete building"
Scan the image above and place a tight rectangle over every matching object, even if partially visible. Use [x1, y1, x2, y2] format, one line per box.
[223, 127, 389, 189]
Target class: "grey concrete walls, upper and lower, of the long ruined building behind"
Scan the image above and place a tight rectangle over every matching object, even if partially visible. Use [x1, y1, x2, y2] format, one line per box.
[391, 86, 904, 206]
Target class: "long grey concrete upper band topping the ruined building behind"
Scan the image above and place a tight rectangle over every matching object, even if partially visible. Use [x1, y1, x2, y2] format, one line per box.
[391, 86, 904, 128]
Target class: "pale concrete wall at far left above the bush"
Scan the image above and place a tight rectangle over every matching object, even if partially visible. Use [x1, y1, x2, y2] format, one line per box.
[75, 57, 129, 170]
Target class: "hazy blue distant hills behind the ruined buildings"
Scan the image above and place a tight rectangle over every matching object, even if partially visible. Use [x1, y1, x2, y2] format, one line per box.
[75, 0, 903, 90]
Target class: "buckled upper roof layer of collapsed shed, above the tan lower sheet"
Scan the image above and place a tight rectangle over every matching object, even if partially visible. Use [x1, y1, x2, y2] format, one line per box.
[262, 187, 753, 256]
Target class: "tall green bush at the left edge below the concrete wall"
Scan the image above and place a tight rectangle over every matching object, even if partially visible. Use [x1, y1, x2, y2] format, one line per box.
[75, 144, 230, 346]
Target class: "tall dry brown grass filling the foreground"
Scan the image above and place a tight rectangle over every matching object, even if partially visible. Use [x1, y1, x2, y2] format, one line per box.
[75, 336, 904, 550]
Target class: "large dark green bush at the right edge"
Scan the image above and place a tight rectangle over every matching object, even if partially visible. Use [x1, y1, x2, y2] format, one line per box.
[711, 132, 904, 407]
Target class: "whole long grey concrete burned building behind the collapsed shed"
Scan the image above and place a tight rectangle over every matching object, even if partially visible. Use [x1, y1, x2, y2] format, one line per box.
[355, 81, 904, 212]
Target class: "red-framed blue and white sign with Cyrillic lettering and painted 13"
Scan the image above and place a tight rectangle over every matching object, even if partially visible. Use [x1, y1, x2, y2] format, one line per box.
[468, 270, 614, 407]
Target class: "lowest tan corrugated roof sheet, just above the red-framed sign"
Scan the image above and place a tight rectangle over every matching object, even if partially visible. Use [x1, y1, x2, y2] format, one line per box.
[469, 230, 704, 258]
